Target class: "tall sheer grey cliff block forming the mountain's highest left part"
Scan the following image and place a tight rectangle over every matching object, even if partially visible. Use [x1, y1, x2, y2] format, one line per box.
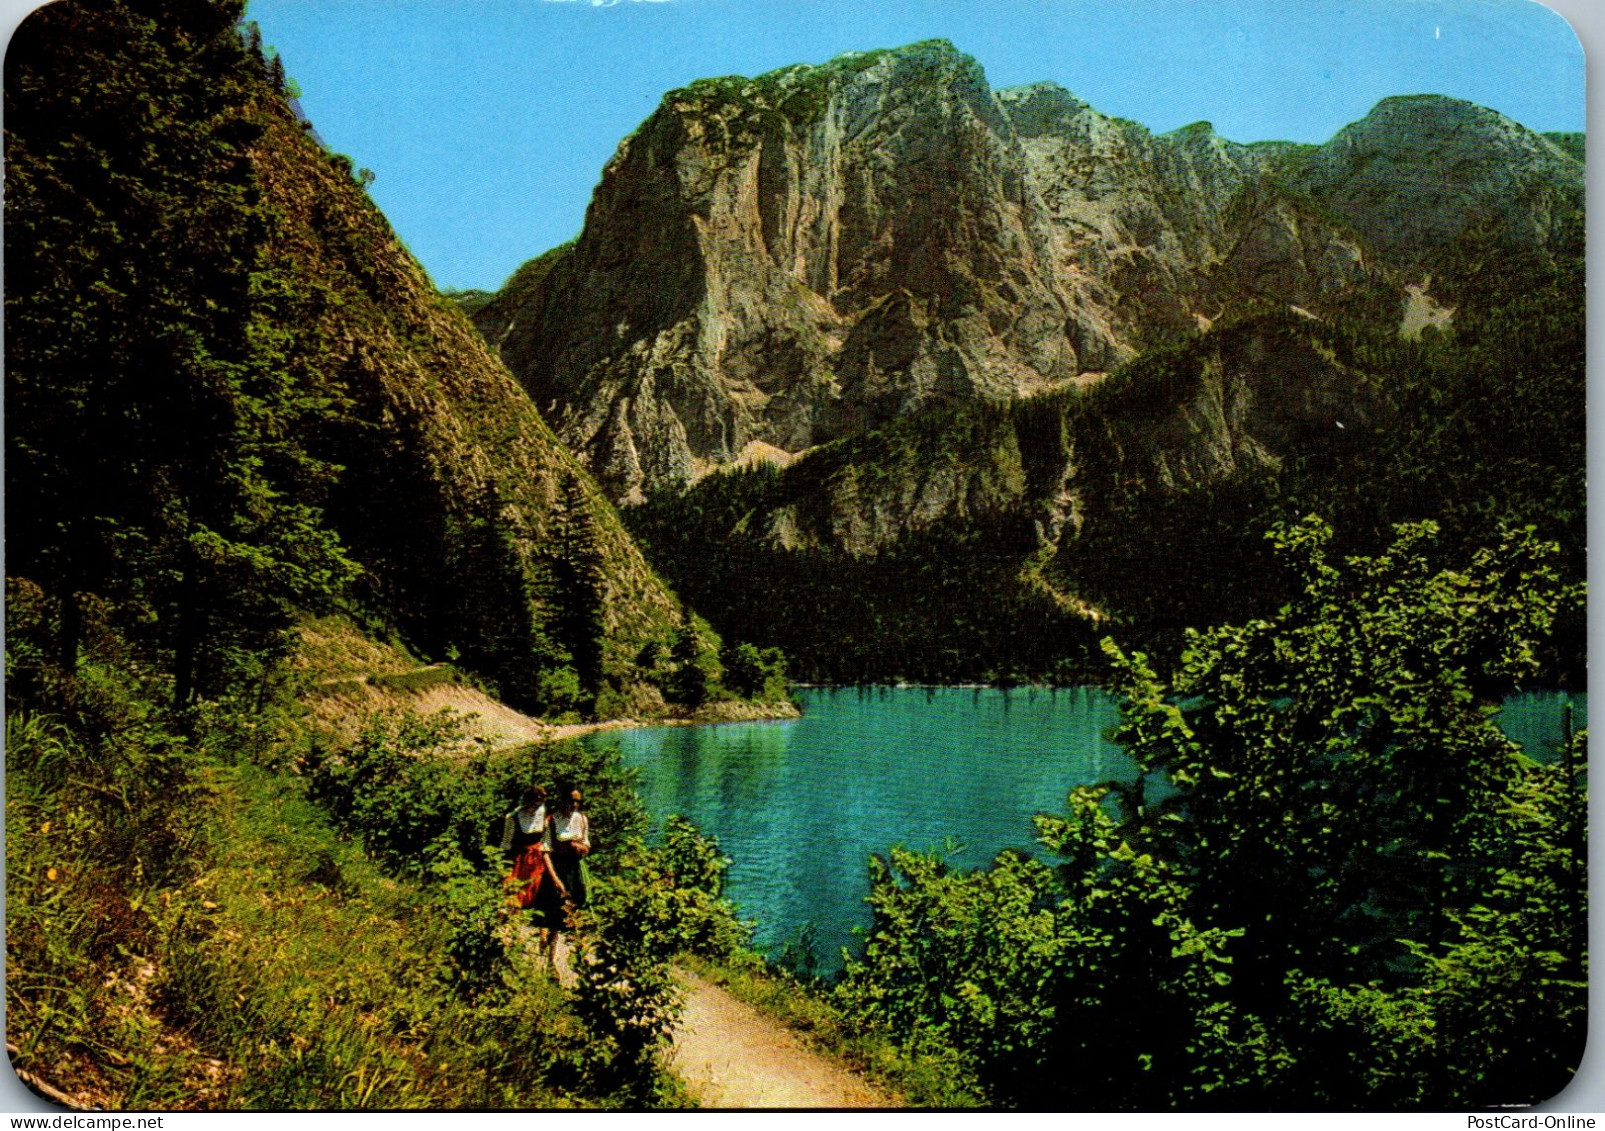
[497, 43, 1127, 499]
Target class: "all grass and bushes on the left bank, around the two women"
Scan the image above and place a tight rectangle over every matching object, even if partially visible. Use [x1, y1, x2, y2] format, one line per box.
[6, 609, 746, 1110]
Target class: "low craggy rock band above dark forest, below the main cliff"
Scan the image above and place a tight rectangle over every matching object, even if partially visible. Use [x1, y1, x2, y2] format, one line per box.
[745, 316, 1388, 555]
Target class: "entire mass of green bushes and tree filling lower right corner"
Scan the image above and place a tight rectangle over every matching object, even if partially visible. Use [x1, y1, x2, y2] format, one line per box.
[836, 520, 1586, 1109]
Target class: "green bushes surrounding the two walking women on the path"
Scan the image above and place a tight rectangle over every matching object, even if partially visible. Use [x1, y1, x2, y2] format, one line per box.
[307, 715, 750, 1105]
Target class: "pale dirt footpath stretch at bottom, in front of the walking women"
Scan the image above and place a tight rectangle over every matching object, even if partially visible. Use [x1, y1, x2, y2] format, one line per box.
[669, 971, 897, 1107]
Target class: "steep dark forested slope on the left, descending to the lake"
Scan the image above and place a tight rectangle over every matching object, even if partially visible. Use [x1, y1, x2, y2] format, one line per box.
[6, 3, 711, 711]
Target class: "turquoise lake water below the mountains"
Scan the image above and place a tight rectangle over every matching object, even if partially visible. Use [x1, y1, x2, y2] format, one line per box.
[586, 687, 1587, 971]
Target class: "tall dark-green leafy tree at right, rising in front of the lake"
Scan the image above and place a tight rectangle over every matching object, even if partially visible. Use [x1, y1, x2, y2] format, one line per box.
[1084, 520, 1581, 1104]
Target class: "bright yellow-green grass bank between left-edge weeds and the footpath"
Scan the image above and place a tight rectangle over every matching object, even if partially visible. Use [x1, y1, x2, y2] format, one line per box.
[151, 754, 575, 1109]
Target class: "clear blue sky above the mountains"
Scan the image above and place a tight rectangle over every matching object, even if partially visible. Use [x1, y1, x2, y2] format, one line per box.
[249, 0, 1584, 289]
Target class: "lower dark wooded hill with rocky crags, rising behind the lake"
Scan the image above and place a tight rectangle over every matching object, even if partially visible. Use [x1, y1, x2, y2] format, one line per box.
[626, 311, 1395, 682]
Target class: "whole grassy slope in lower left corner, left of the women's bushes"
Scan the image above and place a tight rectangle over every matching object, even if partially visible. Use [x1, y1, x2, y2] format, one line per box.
[6, 693, 586, 1110]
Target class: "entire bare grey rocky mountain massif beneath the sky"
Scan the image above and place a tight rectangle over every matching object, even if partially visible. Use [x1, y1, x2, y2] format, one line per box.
[475, 40, 1581, 502]
